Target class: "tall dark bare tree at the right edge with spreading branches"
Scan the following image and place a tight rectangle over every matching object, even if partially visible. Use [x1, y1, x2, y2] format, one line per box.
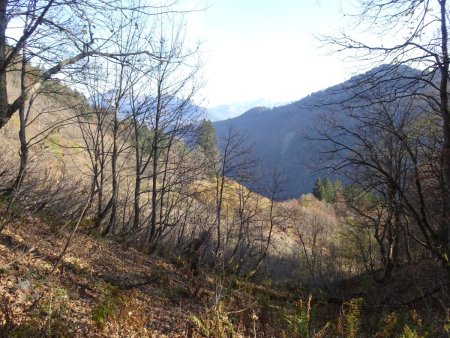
[326, 0, 450, 274]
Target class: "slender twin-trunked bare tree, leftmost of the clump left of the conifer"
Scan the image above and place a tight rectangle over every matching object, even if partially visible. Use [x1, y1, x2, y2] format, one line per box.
[78, 56, 136, 236]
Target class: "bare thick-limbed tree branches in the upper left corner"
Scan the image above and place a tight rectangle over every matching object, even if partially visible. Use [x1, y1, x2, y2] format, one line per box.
[0, 0, 179, 129]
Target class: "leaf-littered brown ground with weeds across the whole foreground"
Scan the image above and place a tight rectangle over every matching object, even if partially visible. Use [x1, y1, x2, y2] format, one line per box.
[0, 207, 450, 337]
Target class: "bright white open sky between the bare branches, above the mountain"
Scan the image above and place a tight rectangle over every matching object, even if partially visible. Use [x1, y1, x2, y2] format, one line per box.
[187, 0, 352, 107]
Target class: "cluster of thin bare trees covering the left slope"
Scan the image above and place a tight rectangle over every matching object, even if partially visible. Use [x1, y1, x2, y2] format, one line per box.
[0, 1, 296, 282]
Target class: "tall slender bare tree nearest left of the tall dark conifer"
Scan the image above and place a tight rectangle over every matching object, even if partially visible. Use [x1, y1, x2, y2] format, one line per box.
[142, 16, 202, 251]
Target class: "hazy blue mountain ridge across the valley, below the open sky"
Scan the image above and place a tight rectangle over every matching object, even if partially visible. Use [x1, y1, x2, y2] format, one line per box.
[214, 65, 423, 198]
